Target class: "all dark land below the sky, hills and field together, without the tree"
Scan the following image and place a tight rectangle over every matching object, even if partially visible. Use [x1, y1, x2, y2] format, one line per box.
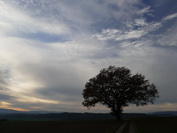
[0, 109, 177, 133]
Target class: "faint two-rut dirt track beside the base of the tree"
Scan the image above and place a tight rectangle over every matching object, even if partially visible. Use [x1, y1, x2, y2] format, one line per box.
[115, 122, 137, 133]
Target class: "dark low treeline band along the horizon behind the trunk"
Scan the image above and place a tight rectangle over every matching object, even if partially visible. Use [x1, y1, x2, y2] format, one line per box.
[0, 113, 147, 121]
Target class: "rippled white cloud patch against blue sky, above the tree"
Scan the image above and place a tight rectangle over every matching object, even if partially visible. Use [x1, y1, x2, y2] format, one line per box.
[93, 18, 161, 41]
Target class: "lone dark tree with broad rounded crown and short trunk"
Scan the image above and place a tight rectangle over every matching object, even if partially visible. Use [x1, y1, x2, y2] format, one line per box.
[82, 66, 159, 120]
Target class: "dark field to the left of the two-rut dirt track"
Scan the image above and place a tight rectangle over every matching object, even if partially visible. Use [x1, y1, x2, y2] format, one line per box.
[0, 120, 120, 133]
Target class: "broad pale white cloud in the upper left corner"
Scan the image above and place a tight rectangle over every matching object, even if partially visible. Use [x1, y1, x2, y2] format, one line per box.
[0, 1, 70, 41]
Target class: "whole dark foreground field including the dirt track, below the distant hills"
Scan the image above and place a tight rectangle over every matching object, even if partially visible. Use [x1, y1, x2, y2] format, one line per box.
[0, 117, 177, 133]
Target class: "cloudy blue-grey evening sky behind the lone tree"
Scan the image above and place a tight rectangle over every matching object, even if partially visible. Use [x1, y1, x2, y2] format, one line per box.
[0, 0, 177, 112]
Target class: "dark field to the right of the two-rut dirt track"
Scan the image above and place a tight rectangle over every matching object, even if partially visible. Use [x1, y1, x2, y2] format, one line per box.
[135, 117, 177, 133]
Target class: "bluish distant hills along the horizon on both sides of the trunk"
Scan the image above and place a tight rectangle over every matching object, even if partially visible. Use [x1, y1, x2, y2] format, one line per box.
[0, 109, 177, 121]
